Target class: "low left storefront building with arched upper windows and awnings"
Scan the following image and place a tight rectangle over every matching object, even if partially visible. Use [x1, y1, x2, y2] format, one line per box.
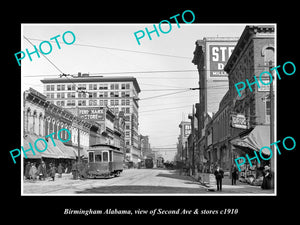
[22, 88, 91, 167]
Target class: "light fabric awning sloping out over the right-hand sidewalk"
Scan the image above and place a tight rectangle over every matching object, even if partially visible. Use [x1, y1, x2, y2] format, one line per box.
[230, 125, 270, 156]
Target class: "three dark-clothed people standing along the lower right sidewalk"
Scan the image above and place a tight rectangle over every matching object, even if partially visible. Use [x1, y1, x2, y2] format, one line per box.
[214, 165, 273, 191]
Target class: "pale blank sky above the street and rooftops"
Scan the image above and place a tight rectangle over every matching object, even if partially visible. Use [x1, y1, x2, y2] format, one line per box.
[21, 23, 245, 156]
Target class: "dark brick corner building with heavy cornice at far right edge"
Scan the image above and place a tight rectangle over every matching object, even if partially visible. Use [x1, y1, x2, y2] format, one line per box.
[224, 25, 276, 181]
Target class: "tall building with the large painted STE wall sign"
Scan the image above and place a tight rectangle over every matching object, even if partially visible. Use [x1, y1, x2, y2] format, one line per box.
[192, 37, 239, 134]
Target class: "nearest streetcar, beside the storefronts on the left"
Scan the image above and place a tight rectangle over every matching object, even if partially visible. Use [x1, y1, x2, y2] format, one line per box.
[86, 144, 124, 178]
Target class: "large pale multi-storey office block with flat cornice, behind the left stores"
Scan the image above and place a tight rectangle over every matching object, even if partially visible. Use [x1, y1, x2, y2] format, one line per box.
[41, 73, 141, 163]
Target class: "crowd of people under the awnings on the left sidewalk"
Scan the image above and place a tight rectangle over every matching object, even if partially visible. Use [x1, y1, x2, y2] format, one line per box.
[24, 161, 64, 181]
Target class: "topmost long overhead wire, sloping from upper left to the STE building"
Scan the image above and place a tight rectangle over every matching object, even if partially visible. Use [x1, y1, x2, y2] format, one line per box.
[25, 38, 191, 59]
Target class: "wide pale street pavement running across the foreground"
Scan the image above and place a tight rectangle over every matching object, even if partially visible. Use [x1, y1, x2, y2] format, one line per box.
[23, 169, 272, 195]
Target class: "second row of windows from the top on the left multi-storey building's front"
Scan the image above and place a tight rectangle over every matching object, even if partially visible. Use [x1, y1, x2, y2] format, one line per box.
[46, 91, 130, 99]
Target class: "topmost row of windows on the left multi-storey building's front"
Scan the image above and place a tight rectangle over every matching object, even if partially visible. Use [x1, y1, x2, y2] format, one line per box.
[46, 83, 130, 91]
